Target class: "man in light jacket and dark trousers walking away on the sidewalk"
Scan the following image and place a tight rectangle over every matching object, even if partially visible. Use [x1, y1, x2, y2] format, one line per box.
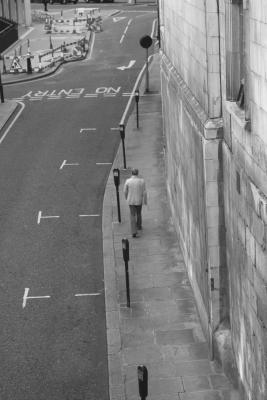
[123, 168, 147, 237]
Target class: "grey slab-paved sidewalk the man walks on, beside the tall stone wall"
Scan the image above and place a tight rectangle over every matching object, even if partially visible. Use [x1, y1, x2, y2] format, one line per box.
[103, 56, 239, 400]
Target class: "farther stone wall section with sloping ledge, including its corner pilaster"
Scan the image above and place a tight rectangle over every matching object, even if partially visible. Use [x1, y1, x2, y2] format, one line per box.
[161, 0, 229, 349]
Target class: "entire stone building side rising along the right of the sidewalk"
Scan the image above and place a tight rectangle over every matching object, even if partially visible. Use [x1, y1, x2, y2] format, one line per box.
[159, 0, 267, 400]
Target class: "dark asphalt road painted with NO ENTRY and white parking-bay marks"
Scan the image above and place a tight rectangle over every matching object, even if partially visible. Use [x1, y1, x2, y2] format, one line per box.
[0, 5, 156, 400]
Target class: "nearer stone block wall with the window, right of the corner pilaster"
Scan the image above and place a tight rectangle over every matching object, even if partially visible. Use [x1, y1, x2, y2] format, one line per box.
[221, 0, 267, 400]
